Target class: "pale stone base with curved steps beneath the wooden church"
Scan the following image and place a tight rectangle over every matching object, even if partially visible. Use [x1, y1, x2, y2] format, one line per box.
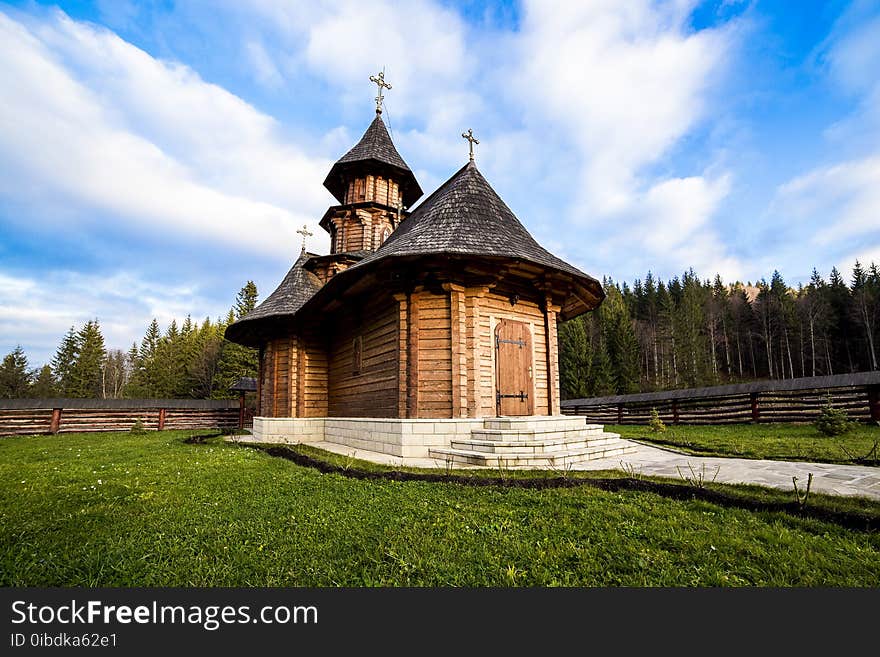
[244, 415, 635, 469]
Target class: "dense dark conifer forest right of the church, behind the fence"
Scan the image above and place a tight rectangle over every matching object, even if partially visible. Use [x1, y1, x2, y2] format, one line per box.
[559, 262, 880, 399]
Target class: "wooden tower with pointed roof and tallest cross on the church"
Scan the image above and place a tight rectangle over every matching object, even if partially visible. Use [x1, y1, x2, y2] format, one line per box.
[320, 73, 422, 255]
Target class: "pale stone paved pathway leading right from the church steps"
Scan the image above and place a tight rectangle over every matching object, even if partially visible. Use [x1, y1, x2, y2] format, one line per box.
[296, 441, 880, 500]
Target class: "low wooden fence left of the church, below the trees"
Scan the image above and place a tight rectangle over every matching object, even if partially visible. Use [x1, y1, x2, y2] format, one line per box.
[0, 399, 246, 436]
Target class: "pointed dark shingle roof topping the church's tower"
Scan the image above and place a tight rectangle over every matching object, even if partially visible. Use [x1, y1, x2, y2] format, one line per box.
[324, 114, 422, 207]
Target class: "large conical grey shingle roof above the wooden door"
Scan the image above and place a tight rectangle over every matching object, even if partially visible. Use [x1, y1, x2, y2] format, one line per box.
[349, 162, 598, 286]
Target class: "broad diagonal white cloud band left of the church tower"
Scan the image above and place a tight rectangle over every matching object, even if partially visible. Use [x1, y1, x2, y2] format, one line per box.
[0, 12, 330, 257]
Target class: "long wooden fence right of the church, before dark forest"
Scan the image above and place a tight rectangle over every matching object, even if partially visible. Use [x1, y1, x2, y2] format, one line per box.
[562, 372, 880, 424]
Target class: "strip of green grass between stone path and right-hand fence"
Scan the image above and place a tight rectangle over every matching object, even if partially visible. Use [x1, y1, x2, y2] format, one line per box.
[606, 424, 880, 465]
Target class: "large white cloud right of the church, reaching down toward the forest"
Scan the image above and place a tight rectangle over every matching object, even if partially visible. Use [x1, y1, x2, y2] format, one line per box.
[501, 0, 739, 278]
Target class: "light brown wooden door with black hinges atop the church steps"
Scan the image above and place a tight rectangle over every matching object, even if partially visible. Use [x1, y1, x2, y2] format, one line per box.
[495, 319, 534, 415]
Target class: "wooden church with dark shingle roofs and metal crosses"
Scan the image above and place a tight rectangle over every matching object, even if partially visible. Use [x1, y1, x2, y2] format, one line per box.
[226, 76, 632, 466]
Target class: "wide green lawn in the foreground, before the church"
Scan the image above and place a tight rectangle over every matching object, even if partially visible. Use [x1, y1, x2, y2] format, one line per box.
[0, 431, 880, 586]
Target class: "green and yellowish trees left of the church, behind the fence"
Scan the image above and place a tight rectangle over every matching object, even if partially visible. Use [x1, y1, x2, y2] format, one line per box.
[0, 281, 258, 399]
